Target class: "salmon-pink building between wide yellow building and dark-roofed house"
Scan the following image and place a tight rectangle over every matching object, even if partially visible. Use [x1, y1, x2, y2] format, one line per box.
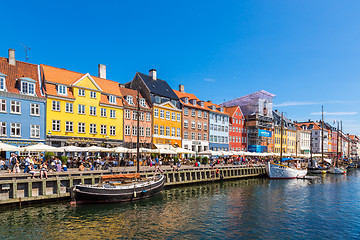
[120, 87, 152, 148]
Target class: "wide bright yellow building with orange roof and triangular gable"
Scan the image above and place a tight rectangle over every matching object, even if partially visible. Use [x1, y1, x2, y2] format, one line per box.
[41, 65, 123, 147]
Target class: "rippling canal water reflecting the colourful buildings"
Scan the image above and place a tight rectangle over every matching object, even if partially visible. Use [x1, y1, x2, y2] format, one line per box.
[0, 170, 360, 239]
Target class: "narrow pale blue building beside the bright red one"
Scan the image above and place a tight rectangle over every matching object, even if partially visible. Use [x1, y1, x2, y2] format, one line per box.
[205, 101, 229, 151]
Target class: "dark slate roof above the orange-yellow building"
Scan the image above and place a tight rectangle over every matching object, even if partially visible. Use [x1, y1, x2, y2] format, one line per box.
[136, 72, 179, 100]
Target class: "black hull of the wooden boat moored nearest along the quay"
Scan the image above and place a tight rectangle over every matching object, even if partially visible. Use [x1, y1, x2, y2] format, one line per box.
[71, 176, 165, 204]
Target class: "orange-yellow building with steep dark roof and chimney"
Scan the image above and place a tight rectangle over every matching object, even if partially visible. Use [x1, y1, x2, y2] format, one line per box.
[125, 69, 182, 148]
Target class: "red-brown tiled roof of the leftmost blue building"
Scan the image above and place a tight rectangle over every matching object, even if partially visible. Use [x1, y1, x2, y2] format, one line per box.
[0, 57, 45, 97]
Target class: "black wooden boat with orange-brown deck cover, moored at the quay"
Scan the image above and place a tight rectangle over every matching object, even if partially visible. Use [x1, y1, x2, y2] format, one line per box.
[70, 173, 165, 204]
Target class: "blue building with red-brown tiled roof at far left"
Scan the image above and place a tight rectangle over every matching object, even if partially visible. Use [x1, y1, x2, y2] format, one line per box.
[0, 49, 46, 158]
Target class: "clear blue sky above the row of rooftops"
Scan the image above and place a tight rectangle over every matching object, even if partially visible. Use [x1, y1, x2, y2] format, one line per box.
[0, 0, 360, 134]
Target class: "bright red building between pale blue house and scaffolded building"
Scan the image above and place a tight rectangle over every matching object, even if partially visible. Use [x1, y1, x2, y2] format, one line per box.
[225, 106, 247, 151]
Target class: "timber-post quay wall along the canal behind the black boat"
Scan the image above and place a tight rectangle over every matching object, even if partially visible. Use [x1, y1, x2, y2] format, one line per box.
[0, 165, 265, 205]
